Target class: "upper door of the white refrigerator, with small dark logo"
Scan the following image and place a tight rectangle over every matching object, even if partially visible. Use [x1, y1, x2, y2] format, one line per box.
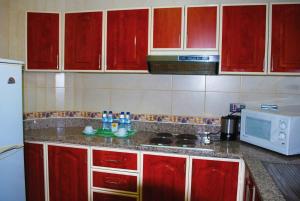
[0, 60, 23, 147]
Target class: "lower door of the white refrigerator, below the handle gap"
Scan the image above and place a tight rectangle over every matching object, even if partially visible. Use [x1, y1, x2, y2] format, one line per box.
[0, 148, 26, 201]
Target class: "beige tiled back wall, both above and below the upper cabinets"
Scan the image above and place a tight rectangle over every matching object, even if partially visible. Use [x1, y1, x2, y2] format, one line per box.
[9, 0, 300, 116]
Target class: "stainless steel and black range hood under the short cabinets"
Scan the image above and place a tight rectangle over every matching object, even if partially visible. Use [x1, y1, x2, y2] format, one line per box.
[147, 55, 219, 75]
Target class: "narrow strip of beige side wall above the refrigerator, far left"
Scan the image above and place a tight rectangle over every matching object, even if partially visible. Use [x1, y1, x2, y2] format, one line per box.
[0, 0, 9, 58]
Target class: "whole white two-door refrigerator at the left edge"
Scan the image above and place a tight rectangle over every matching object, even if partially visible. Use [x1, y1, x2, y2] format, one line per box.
[0, 58, 26, 201]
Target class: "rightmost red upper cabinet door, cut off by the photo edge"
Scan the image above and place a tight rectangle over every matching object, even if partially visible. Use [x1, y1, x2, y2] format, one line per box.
[269, 3, 300, 74]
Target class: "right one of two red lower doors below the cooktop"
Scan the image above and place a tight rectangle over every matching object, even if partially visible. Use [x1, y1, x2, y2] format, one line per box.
[191, 159, 239, 201]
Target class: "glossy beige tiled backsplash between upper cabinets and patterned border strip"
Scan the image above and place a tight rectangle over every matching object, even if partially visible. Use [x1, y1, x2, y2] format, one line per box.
[24, 72, 300, 116]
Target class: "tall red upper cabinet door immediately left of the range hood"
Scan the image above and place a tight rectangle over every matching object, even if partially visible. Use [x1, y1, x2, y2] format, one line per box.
[106, 9, 149, 71]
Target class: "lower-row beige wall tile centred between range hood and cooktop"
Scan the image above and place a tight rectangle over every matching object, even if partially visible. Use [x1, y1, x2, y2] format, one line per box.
[172, 91, 205, 116]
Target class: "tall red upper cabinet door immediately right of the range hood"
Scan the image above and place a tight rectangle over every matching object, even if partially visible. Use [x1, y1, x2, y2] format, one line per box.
[221, 4, 267, 74]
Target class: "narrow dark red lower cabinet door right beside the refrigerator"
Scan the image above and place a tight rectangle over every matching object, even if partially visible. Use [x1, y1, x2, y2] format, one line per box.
[24, 143, 45, 201]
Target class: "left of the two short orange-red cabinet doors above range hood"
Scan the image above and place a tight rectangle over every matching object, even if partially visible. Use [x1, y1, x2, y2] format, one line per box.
[152, 7, 183, 49]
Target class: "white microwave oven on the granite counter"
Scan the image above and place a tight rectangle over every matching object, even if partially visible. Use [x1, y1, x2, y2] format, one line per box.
[240, 109, 300, 155]
